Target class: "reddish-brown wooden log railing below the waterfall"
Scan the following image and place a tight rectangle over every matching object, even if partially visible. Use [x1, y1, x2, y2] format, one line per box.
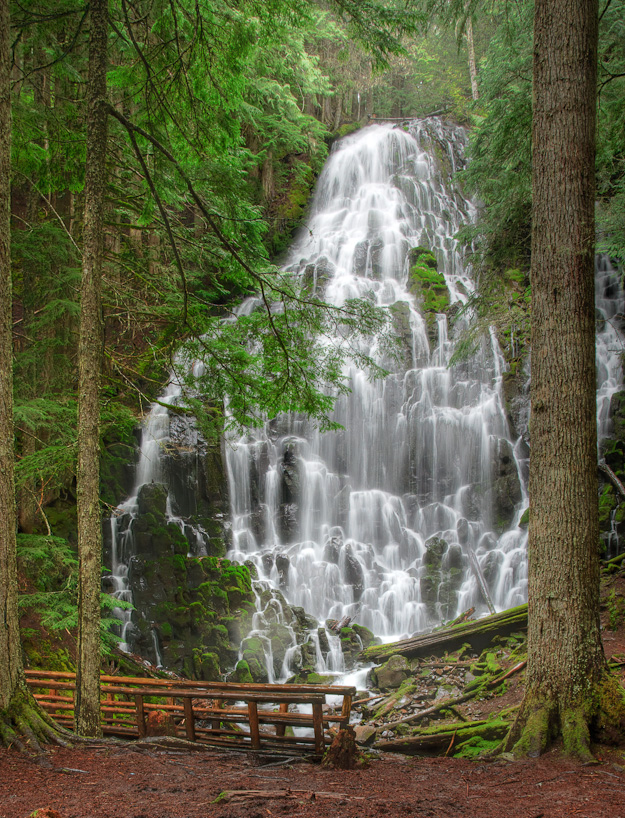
[26, 670, 356, 756]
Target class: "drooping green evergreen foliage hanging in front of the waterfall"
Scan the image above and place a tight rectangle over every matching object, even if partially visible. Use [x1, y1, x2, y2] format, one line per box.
[178, 288, 387, 435]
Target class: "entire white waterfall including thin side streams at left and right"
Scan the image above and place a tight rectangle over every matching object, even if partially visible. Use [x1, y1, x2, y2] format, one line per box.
[105, 119, 625, 686]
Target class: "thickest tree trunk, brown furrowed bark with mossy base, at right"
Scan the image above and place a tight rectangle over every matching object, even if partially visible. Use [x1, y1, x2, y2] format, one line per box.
[508, 0, 622, 759]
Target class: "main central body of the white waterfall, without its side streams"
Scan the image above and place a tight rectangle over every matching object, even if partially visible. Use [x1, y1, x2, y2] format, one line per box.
[227, 120, 526, 652]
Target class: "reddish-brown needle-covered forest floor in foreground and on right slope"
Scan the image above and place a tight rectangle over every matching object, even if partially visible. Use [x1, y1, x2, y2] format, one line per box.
[7, 568, 625, 818]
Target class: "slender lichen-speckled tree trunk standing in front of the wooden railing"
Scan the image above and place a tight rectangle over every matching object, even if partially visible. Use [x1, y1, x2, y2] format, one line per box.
[76, 0, 108, 736]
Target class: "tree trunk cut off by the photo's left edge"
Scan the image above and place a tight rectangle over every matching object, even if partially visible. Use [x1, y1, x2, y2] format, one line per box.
[0, 0, 23, 710]
